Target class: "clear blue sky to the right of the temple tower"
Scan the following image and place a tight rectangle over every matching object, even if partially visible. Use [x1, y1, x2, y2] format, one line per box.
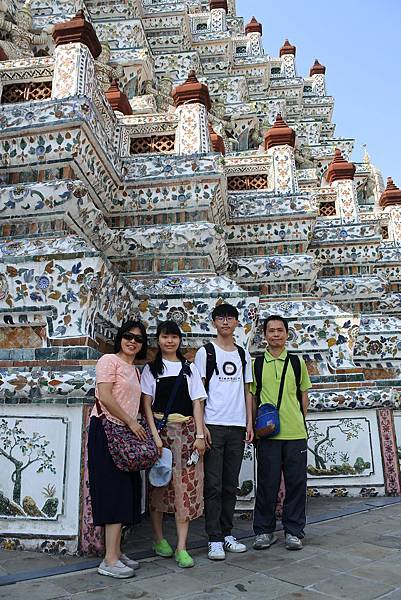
[237, 0, 401, 187]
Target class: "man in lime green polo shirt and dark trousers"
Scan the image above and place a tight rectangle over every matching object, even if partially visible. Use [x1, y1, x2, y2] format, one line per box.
[251, 315, 312, 550]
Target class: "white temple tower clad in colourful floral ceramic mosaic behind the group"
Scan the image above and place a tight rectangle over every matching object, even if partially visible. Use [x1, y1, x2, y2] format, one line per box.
[0, 0, 401, 553]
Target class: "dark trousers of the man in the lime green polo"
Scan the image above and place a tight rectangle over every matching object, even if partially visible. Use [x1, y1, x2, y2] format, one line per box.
[253, 438, 307, 538]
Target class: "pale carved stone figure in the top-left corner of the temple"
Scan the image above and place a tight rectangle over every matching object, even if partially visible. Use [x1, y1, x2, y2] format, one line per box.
[0, 0, 48, 59]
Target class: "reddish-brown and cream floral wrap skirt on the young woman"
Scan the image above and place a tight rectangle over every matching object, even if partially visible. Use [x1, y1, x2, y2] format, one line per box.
[150, 418, 203, 521]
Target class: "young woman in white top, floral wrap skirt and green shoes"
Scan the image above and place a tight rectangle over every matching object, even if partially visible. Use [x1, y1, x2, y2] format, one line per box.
[141, 321, 206, 568]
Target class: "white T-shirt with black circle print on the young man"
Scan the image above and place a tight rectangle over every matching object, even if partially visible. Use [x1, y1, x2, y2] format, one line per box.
[195, 343, 252, 427]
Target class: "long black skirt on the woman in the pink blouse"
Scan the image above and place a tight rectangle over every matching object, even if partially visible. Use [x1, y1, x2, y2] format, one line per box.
[88, 417, 142, 526]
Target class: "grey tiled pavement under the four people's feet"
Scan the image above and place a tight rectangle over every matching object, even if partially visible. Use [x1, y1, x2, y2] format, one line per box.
[0, 498, 401, 600]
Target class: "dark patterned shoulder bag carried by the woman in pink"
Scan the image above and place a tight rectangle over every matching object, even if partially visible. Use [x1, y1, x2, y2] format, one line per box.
[96, 398, 159, 471]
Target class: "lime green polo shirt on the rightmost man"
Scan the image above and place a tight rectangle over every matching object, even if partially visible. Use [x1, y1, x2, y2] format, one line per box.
[251, 350, 312, 440]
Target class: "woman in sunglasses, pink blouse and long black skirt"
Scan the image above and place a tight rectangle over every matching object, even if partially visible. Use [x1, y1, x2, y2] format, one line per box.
[88, 321, 147, 578]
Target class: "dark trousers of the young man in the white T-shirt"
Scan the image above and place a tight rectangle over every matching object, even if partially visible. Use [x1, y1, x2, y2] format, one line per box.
[204, 425, 245, 542]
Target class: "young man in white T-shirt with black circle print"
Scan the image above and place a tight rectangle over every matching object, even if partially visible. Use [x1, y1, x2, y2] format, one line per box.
[195, 304, 253, 560]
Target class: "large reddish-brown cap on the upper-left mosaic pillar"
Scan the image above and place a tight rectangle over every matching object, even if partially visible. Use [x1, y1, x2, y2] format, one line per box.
[52, 10, 102, 58]
